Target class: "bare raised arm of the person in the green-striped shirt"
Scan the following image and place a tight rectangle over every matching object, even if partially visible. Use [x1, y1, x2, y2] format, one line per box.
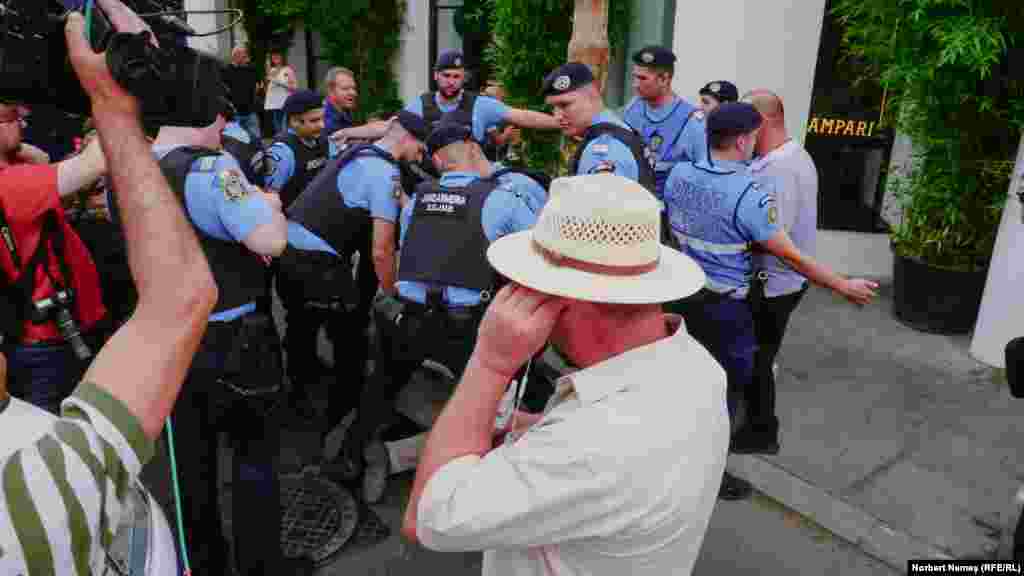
[67, 14, 217, 439]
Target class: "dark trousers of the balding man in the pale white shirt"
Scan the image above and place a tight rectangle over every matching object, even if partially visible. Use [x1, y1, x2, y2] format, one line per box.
[744, 285, 807, 439]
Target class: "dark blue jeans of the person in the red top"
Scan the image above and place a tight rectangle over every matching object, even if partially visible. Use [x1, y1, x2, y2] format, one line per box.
[5, 344, 89, 414]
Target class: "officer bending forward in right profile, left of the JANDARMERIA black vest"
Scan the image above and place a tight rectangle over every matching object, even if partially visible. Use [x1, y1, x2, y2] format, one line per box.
[278, 112, 428, 444]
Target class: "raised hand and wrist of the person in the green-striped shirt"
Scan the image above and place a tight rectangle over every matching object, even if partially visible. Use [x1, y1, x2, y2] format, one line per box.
[65, 13, 138, 116]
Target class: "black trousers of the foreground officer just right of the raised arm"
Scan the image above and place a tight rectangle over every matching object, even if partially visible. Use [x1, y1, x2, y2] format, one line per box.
[172, 323, 284, 576]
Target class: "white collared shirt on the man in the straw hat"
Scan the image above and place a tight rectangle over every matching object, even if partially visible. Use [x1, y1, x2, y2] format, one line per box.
[417, 316, 729, 576]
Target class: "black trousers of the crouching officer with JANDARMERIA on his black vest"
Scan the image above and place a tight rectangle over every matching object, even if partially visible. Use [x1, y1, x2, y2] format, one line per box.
[345, 302, 480, 456]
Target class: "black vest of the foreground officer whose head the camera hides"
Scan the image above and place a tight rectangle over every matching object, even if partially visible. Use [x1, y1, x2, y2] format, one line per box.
[160, 147, 266, 313]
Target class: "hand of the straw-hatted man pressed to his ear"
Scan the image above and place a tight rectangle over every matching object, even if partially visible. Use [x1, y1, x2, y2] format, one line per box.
[473, 283, 569, 381]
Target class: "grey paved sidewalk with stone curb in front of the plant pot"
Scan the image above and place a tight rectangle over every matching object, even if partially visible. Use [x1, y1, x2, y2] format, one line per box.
[729, 284, 1024, 570]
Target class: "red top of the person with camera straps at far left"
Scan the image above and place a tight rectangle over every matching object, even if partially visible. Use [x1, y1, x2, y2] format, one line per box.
[0, 164, 106, 343]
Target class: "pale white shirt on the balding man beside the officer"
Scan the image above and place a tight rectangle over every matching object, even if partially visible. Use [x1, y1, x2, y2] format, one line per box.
[751, 140, 818, 298]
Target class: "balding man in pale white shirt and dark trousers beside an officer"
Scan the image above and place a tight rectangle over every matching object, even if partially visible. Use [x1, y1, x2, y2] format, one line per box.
[732, 89, 818, 454]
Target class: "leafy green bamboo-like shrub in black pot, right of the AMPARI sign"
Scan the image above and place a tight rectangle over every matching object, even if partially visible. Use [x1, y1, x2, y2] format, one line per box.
[834, 0, 1024, 333]
